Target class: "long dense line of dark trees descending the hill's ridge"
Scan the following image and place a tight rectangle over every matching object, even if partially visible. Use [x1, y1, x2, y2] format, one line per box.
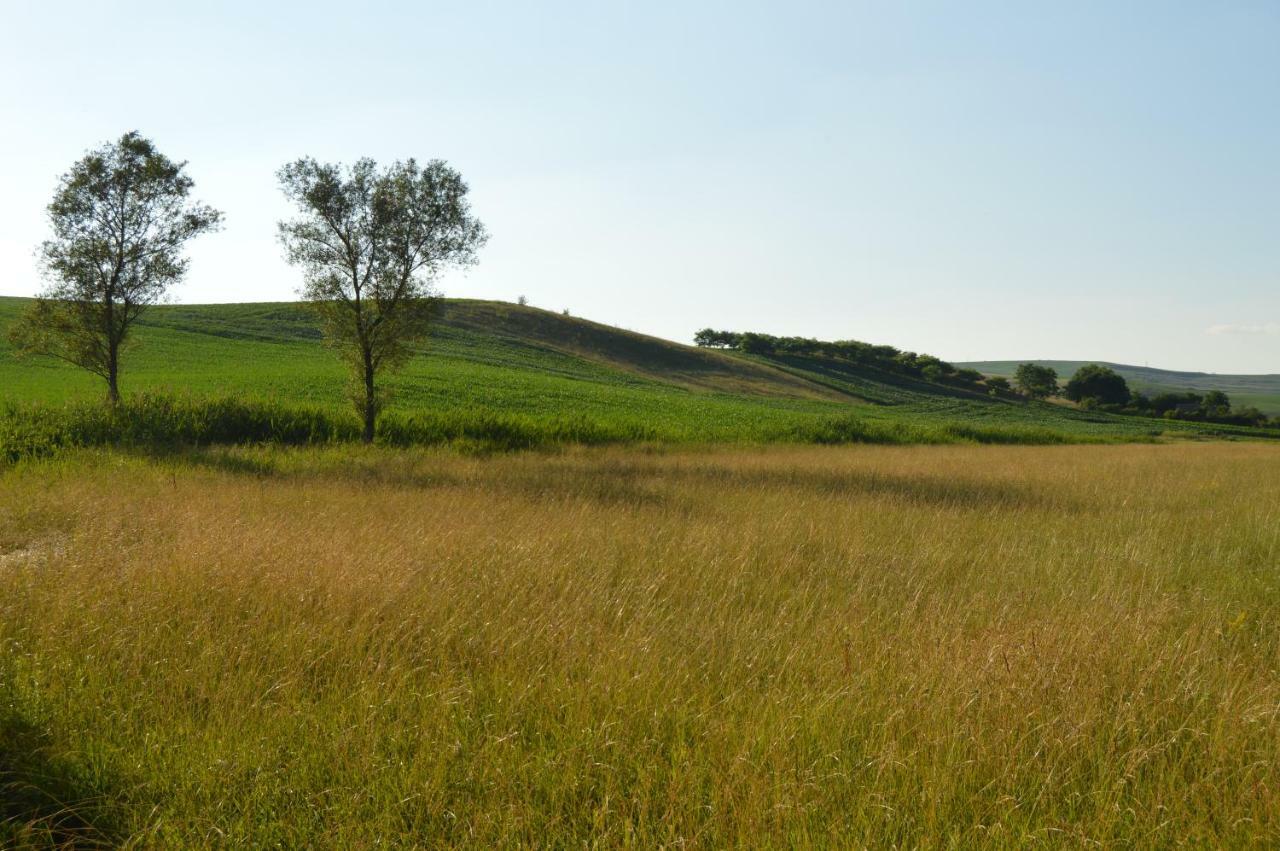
[694, 328, 988, 393]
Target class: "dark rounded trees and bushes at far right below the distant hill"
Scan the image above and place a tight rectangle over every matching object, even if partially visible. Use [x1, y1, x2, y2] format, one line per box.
[1013, 363, 1280, 427]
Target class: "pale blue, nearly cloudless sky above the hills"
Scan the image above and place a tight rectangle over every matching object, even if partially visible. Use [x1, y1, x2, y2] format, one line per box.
[0, 0, 1280, 372]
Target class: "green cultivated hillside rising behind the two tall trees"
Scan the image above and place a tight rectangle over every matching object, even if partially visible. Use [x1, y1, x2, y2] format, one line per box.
[0, 298, 1269, 441]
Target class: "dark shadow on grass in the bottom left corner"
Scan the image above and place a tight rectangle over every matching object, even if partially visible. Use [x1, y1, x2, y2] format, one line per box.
[0, 708, 119, 848]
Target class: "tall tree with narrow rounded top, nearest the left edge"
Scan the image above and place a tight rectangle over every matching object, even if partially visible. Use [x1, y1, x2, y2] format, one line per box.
[9, 132, 221, 404]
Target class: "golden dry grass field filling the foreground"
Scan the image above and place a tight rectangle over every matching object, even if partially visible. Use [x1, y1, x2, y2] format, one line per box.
[0, 443, 1280, 848]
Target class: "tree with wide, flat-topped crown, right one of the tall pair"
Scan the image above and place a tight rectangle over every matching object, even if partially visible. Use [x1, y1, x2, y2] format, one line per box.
[278, 157, 488, 443]
